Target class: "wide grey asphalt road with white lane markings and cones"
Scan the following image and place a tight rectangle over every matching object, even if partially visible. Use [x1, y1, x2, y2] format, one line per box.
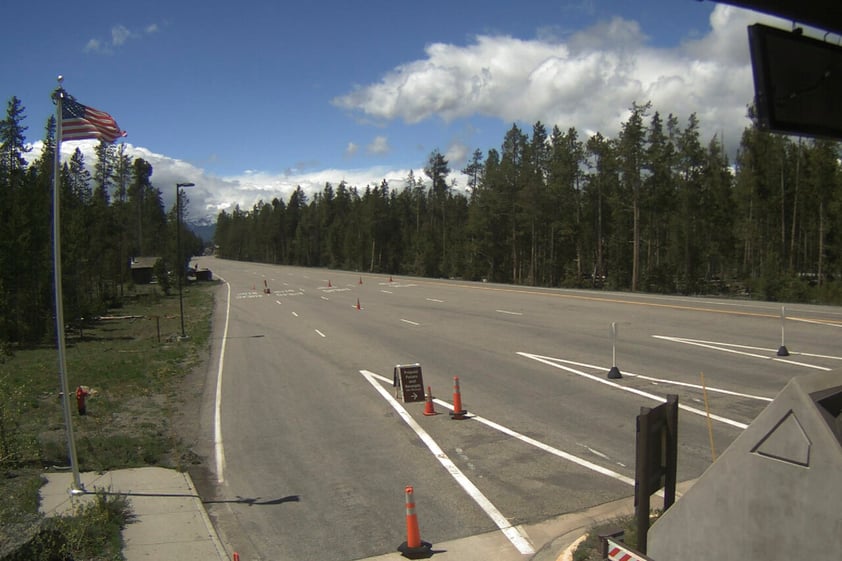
[187, 258, 842, 561]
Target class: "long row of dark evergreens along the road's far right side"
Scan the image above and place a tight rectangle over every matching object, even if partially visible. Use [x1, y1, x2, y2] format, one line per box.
[215, 103, 842, 303]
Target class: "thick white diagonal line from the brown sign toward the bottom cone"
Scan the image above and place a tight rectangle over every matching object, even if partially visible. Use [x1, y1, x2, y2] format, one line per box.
[360, 370, 535, 555]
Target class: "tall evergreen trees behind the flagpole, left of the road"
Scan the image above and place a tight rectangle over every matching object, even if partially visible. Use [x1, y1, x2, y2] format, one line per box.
[0, 97, 202, 345]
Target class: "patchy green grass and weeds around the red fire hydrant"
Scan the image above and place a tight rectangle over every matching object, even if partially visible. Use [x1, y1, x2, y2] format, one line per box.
[0, 283, 215, 561]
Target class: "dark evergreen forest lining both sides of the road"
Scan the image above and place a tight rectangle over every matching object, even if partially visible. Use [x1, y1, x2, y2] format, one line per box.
[0, 97, 842, 344]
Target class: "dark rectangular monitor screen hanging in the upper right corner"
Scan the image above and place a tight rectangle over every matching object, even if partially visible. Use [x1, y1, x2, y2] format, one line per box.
[748, 24, 842, 139]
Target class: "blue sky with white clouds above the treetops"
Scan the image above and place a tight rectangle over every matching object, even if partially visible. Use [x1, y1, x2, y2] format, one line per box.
[0, 0, 792, 221]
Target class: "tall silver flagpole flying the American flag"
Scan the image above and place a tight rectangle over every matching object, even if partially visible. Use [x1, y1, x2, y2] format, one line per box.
[53, 76, 85, 495]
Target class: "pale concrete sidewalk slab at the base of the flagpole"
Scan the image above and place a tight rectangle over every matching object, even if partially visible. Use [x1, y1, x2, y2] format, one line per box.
[40, 467, 228, 561]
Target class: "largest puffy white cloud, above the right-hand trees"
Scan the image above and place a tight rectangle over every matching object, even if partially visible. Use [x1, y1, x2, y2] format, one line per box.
[333, 5, 792, 149]
